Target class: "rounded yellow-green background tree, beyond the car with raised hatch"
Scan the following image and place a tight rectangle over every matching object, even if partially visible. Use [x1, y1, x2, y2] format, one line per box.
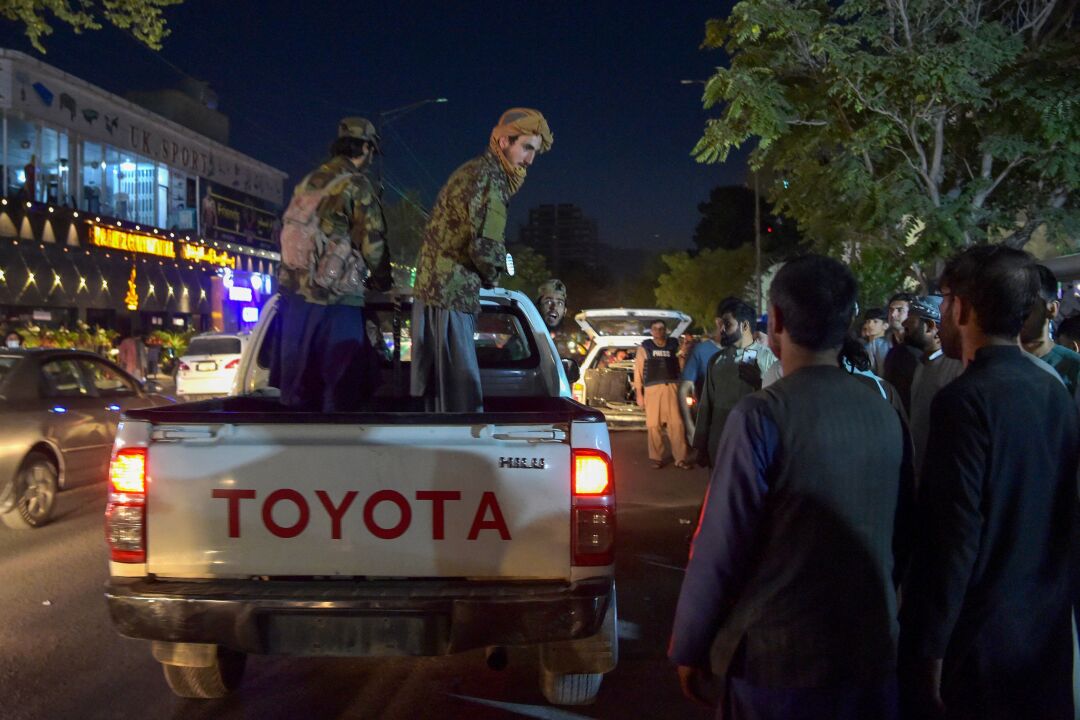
[656, 245, 754, 328]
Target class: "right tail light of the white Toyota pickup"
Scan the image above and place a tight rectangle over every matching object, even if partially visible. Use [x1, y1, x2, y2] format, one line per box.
[570, 449, 615, 566]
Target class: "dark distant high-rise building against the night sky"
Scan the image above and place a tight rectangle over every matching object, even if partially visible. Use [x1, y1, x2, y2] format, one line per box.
[518, 203, 599, 276]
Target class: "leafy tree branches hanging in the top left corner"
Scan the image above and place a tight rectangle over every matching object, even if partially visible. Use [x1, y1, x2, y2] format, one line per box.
[0, 0, 184, 53]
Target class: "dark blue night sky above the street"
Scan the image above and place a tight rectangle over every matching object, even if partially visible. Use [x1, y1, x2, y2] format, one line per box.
[0, 0, 745, 249]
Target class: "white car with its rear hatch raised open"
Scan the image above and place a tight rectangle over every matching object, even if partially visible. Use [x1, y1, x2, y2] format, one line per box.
[572, 308, 690, 430]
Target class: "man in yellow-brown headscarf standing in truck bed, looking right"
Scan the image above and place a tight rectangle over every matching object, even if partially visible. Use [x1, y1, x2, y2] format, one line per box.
[411, 108, 553, 412]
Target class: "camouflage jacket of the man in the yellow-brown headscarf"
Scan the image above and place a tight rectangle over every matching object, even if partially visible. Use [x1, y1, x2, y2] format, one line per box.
[414, 152, 510, 313]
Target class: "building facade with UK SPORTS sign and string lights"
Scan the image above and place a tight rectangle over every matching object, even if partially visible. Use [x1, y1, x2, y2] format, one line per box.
[0, 50, 285, 332]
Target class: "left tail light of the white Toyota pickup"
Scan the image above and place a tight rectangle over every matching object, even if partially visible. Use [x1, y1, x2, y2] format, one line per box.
[105, 448, 146, 562]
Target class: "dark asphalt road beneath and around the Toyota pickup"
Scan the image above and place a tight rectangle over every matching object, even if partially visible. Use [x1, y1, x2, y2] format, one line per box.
[0, 432, 711, 720]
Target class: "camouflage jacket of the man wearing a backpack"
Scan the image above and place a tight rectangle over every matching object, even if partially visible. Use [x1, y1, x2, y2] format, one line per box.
[278, 157, 390, 305]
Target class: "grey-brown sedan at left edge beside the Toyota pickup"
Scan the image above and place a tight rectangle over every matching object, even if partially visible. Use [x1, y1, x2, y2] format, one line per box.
[0, 349, 174, 529]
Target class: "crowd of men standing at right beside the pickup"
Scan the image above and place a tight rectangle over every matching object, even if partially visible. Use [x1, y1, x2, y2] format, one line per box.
[669, 245, 1080, 720]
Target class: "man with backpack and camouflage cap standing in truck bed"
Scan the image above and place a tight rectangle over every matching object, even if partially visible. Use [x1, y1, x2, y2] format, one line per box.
[270, 118, 391, 412]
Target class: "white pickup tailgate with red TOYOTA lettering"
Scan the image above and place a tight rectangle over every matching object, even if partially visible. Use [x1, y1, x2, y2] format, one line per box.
[146, 423, 570, 579]
